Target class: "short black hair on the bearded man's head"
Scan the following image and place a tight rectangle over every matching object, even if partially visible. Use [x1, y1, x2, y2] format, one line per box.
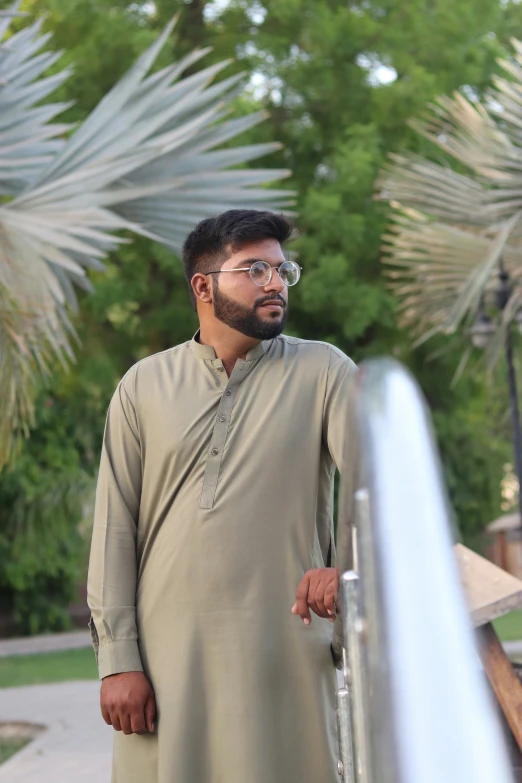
[183, 209, 293, 309]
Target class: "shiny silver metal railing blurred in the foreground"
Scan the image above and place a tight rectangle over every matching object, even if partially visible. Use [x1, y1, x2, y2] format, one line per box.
[338, 359, 513, 783]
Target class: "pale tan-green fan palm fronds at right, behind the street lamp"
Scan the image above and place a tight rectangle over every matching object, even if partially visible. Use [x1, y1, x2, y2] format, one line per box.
[378, 40, 522, 370]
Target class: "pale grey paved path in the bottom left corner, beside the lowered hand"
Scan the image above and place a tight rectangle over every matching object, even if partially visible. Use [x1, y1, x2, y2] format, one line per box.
[0, 681, 111, 783]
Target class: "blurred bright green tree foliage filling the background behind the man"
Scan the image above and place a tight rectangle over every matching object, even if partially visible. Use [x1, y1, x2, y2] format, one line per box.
[0, 0, 522, 629]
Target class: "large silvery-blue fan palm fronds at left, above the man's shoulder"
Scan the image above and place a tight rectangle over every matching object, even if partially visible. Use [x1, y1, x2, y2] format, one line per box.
[0, 3, 292, 466]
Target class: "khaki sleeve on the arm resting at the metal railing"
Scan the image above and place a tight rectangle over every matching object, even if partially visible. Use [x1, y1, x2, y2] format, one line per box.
[323, 349, 361, 667]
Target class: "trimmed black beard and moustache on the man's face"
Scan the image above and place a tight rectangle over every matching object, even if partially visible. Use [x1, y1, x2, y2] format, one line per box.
[212, 280, 288, 340]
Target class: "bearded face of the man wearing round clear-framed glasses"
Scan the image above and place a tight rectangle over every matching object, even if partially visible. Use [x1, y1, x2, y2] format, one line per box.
[212, 239, 288, 340]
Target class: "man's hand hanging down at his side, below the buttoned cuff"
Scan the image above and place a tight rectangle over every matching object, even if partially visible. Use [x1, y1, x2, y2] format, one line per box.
[100, 672, 156, 734]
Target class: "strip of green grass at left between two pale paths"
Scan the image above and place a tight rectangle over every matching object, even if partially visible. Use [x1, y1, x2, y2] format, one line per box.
[0, 647, 98, 688]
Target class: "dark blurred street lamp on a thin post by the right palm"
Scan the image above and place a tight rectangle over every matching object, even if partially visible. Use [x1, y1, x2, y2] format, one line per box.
[469, 263, 522, 526]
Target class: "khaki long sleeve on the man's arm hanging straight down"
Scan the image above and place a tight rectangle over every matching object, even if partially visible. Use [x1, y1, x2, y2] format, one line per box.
[87, 378, 143, 679]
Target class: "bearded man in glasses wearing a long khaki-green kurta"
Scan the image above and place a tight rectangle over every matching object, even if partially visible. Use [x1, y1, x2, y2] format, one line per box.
[88, 210, 355, 783]
